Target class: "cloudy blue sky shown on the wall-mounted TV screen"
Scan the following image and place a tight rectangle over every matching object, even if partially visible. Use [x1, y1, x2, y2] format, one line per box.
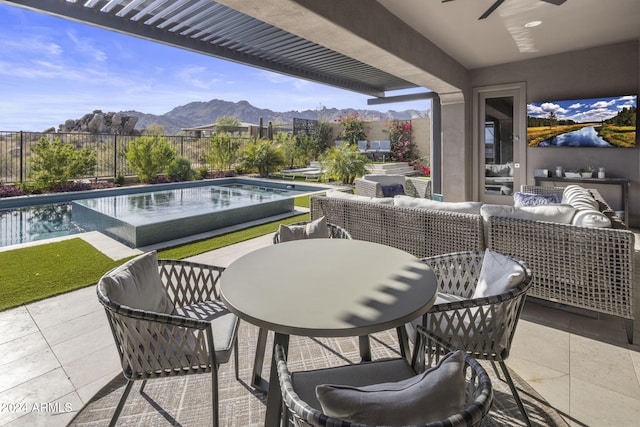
[527, 95, 637, 123]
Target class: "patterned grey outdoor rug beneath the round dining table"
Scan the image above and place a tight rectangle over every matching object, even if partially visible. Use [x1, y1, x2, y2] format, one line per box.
[69, 322, 567, 427]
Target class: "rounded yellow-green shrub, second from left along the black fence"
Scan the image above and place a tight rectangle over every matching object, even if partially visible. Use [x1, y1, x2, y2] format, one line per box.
[127, 136, 176, 183]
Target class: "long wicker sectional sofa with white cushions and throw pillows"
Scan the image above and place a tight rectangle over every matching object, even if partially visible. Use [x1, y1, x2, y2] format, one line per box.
[311, 186, 634, 343]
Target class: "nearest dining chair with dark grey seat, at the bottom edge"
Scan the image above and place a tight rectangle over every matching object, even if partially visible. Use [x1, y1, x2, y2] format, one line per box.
[275, 326, 493, 427]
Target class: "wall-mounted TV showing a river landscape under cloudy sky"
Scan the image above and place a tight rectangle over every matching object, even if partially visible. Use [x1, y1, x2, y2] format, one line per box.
[527, 95, 638, 148]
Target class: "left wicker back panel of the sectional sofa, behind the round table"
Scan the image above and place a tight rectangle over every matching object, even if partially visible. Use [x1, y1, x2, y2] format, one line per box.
[310, 196, 485, 258]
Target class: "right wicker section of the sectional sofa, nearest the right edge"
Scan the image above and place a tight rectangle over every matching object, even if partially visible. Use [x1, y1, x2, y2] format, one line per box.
[487, 186, 635, 343]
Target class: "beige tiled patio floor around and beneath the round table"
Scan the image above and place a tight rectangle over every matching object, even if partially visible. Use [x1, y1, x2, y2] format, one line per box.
[0, 233, 640, 426]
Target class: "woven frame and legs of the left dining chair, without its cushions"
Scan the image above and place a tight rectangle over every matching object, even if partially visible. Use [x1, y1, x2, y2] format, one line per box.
[97, 260, 238, 425]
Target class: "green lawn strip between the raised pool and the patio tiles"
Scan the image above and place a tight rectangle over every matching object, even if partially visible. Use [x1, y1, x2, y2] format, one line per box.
[0, 196, 309, 311]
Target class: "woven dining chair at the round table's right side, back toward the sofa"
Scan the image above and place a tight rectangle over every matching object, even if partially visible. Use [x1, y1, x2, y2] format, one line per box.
[408, 251, 532, 425]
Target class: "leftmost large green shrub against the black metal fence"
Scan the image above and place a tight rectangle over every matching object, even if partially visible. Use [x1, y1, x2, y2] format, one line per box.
[29, 137, 97, 191]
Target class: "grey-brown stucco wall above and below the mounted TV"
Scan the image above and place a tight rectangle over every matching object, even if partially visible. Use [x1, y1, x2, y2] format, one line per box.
[470, 41, 640, 226]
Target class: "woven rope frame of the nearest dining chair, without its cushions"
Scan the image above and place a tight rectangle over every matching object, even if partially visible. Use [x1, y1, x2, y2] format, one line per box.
[275, 327, 493, 427]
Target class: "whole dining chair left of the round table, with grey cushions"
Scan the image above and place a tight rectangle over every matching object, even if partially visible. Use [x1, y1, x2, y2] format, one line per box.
[97, 252, 239, 426]
